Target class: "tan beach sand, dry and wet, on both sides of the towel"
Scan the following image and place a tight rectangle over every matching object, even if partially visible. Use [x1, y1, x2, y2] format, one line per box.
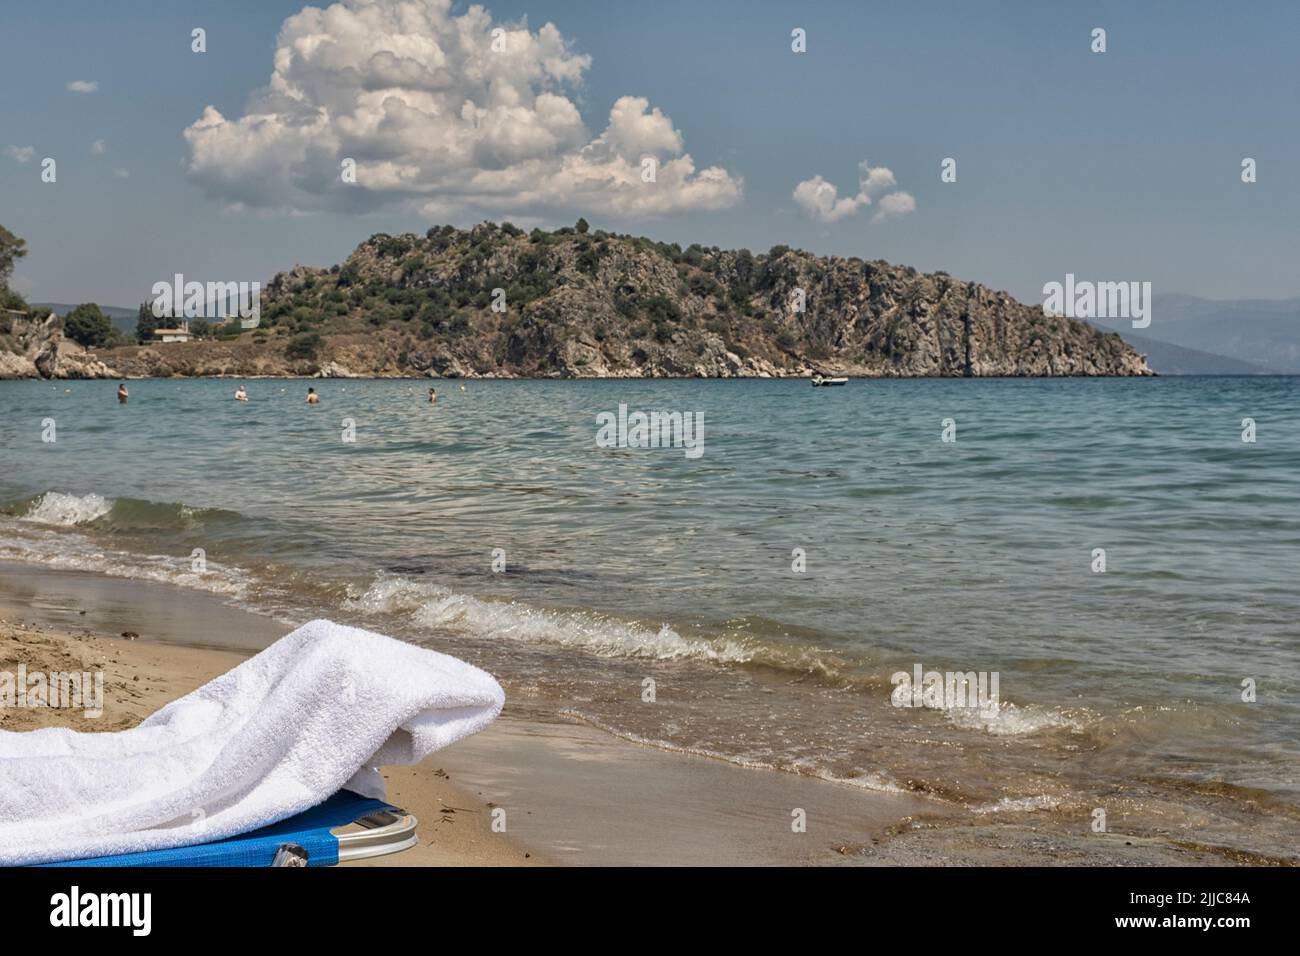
[0, 563, 1286, 866]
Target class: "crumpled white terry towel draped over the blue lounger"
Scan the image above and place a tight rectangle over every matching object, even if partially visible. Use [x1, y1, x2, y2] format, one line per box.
[0, 620, 504, 865]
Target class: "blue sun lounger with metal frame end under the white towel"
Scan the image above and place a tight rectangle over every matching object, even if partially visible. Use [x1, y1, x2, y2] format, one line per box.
[47, 790, 417, 866]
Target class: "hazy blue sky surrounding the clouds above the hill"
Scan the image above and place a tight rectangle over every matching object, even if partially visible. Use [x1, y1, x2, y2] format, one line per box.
[0, 0, 1300, 306]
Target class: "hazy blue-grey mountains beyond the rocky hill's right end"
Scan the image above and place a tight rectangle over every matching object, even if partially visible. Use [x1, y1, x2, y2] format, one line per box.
[1093, 295, 1300, 375]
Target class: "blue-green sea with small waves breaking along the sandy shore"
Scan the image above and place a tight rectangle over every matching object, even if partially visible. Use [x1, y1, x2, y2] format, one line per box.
[0, 378, 1300, 856]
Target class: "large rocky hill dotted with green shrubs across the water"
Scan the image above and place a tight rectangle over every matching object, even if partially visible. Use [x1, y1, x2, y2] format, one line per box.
[38, 221, 1152, 377]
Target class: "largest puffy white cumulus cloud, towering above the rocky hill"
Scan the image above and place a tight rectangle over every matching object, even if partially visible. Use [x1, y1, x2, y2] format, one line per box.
[183, 0, 742, 216]
